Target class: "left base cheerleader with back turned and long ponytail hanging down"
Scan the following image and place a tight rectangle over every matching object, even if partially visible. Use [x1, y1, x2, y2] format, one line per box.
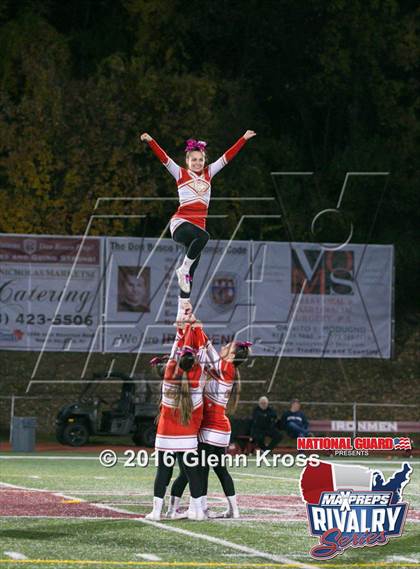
[146, 324, 205, 520]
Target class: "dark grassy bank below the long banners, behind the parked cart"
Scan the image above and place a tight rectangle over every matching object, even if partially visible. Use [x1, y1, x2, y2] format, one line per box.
[0, 323, 420, 434]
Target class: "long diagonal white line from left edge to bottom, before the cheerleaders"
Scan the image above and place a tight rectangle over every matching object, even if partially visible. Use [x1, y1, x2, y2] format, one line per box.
[0, 482, 319, 569]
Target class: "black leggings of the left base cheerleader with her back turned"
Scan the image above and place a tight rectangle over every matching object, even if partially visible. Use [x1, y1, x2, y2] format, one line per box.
[153, 450, 202, 498]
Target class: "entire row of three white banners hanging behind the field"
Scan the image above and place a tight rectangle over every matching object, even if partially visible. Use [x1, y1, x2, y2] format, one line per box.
[0, 235, 394, 358]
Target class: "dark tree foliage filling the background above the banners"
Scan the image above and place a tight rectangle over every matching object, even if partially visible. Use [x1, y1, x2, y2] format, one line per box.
[0, 0, 420, 303]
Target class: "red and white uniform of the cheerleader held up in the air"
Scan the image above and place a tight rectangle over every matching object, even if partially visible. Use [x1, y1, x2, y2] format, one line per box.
[148, 136, 246, 234]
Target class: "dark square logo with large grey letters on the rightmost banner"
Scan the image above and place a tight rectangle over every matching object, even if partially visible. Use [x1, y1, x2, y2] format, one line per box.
[291, 247, 354, 294]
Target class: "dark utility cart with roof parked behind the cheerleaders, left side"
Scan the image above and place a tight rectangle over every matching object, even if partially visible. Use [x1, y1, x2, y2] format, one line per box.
[56, 372, 157, 447]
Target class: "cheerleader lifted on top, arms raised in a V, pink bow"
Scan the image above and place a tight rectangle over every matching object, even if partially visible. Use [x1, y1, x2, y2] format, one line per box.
[140, 130, 256, 321]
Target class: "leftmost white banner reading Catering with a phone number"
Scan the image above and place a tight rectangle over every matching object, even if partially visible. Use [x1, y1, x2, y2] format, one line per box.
[0, 234, 102, 352]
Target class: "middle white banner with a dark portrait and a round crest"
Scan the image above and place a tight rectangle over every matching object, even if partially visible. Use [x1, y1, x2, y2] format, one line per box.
[104, 238, 251, 353]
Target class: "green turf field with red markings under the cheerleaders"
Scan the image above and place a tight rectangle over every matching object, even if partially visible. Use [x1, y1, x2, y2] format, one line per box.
[0, 452, 420, 569]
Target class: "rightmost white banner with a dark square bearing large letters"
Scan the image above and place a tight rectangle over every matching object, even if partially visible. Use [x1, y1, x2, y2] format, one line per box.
[252, 242, 394, 358]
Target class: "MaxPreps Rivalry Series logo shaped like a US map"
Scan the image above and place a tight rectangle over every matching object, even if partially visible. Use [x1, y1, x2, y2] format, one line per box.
[300, 462, 413, 559]
